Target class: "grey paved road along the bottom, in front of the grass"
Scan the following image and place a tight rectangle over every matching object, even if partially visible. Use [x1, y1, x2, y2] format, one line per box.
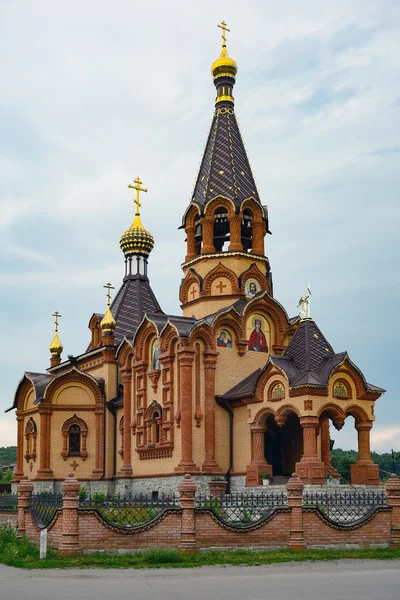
[0, 560, 400, 600]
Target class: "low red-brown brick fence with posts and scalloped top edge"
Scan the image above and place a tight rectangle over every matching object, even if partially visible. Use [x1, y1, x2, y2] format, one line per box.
[18, 473, 400, 556]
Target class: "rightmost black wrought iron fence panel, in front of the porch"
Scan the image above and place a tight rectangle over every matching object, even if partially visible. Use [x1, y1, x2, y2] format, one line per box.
[303, 490, 388, 525]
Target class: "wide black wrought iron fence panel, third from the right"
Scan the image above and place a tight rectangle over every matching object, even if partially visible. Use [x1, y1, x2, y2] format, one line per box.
[79, 493, 179, 530]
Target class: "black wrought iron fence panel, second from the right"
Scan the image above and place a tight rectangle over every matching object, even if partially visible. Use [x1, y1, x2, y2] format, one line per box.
[196, 492, 288, 529]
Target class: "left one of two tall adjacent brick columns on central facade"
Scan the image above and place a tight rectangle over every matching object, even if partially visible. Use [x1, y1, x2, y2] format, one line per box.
[175, 346, 199, 472]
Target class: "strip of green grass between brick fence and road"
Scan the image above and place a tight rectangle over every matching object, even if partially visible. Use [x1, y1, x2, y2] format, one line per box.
[0, 528, 400, 569]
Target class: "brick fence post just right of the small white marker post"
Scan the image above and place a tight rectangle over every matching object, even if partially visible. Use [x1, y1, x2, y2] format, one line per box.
[59, 473, 80, 556]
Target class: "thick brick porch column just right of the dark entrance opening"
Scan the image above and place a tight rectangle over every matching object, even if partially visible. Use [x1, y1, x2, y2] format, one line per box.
[296, 417, 326, 485]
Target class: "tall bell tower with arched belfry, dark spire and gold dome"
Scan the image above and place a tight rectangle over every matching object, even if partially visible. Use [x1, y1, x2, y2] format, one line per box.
[180, 21, 273, 318]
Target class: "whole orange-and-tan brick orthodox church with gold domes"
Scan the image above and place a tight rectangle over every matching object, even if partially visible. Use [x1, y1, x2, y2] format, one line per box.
[9, 22, 384, 492]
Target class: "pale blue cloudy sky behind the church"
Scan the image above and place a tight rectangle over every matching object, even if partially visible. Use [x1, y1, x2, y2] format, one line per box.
[0, 0, 400, 451]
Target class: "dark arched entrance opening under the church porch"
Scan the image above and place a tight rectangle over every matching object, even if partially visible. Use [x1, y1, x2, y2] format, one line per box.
[264, 413, 303, 477]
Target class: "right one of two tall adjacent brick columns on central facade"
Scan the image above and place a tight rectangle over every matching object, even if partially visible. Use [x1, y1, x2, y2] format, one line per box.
[203, 352, 221, 473]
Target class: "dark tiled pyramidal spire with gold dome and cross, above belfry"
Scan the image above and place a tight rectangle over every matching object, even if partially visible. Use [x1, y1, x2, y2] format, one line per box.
[183, 21, 268, 230]
